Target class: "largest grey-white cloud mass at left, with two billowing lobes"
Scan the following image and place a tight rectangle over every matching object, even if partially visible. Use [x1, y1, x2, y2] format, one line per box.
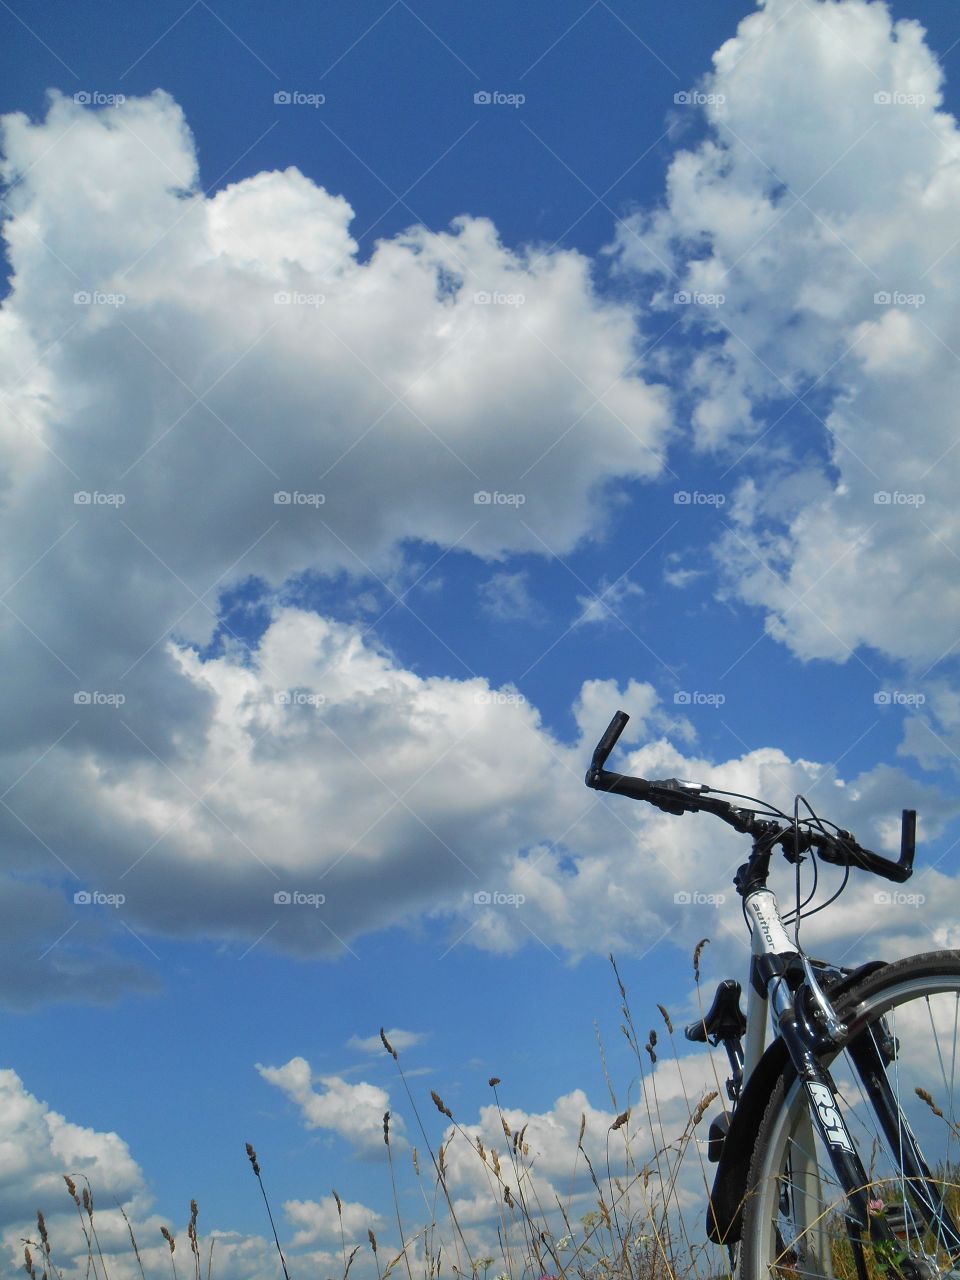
[0, 92, 668, 1004]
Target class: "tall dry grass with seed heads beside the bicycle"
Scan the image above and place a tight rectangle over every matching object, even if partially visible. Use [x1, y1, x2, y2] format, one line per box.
[32, 957, 960, 1280]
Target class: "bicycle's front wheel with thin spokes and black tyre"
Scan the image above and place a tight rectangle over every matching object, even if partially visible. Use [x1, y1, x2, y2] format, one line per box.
[739, 951, 960, 1280]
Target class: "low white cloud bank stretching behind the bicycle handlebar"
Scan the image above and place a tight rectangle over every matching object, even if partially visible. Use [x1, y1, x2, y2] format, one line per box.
[5, 608, 955, 1003]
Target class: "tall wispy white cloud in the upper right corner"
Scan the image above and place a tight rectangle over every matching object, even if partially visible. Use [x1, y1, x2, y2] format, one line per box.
[616, 0, 960, 672]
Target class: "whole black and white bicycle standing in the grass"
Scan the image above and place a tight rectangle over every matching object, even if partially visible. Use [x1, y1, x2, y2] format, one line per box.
[585, 712, 960, 1280]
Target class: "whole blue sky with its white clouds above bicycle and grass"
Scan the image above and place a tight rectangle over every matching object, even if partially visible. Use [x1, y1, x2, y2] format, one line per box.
[0, 0, 960, 1275]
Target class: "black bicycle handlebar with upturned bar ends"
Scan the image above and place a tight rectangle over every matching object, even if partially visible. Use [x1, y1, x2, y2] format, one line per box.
[584, 712, 916, 883]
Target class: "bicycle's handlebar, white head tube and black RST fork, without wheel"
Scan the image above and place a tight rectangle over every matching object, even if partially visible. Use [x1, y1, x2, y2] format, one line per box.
[585, 712, 960, 1280]
